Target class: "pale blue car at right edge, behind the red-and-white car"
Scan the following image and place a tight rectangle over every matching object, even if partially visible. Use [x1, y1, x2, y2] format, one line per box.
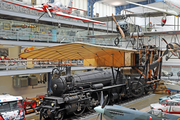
[159, 94, 180, 103]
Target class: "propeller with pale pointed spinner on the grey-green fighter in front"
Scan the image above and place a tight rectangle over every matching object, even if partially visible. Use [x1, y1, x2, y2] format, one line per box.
[94, 91, 108, 120]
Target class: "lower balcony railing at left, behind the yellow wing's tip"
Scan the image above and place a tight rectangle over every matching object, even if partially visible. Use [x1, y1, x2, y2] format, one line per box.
[0, 59, 83, 71]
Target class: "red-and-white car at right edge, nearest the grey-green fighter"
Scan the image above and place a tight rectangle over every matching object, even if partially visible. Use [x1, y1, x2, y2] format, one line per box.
[150, 100, 180, 113]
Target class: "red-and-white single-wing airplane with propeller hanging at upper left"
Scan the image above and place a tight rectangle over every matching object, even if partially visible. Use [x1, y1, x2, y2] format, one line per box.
[2, 0, 105, 25]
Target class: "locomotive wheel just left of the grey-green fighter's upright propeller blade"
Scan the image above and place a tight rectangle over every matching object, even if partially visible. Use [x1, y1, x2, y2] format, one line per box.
[87, 92, 100, 111]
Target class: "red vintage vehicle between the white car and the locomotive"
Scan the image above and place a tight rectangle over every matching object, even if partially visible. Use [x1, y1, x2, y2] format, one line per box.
[24, 95, 45, 114]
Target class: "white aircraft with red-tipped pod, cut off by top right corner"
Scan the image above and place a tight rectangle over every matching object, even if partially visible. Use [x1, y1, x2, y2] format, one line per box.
[126, 0, 180, 26]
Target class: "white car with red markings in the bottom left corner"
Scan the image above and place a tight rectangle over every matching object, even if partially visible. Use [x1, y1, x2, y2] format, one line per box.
[0, 94, 25, 120]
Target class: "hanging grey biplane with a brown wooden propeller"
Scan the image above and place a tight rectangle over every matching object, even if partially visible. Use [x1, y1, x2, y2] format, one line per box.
[86, 12, 180, 46]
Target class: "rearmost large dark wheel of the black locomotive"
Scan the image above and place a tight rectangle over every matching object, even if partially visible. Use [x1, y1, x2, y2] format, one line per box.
[130, 81, 144, 97]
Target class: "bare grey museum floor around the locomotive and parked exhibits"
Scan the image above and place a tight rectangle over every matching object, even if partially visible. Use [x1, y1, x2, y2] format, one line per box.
[26, 94, 180, 120]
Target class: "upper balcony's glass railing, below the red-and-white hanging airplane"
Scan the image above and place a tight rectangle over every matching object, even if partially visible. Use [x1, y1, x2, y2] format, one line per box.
[0, 29, 121, 46]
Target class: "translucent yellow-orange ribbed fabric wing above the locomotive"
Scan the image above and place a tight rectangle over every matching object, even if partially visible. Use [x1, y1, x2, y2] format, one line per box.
[19, 43, 137, 67]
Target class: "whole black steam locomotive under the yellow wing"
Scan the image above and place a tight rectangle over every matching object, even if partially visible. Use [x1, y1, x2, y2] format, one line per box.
[40, 68, 147, 120]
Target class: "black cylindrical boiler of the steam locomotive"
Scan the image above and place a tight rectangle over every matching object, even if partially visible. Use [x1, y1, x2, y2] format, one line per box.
[51, 69, 113, 96]
